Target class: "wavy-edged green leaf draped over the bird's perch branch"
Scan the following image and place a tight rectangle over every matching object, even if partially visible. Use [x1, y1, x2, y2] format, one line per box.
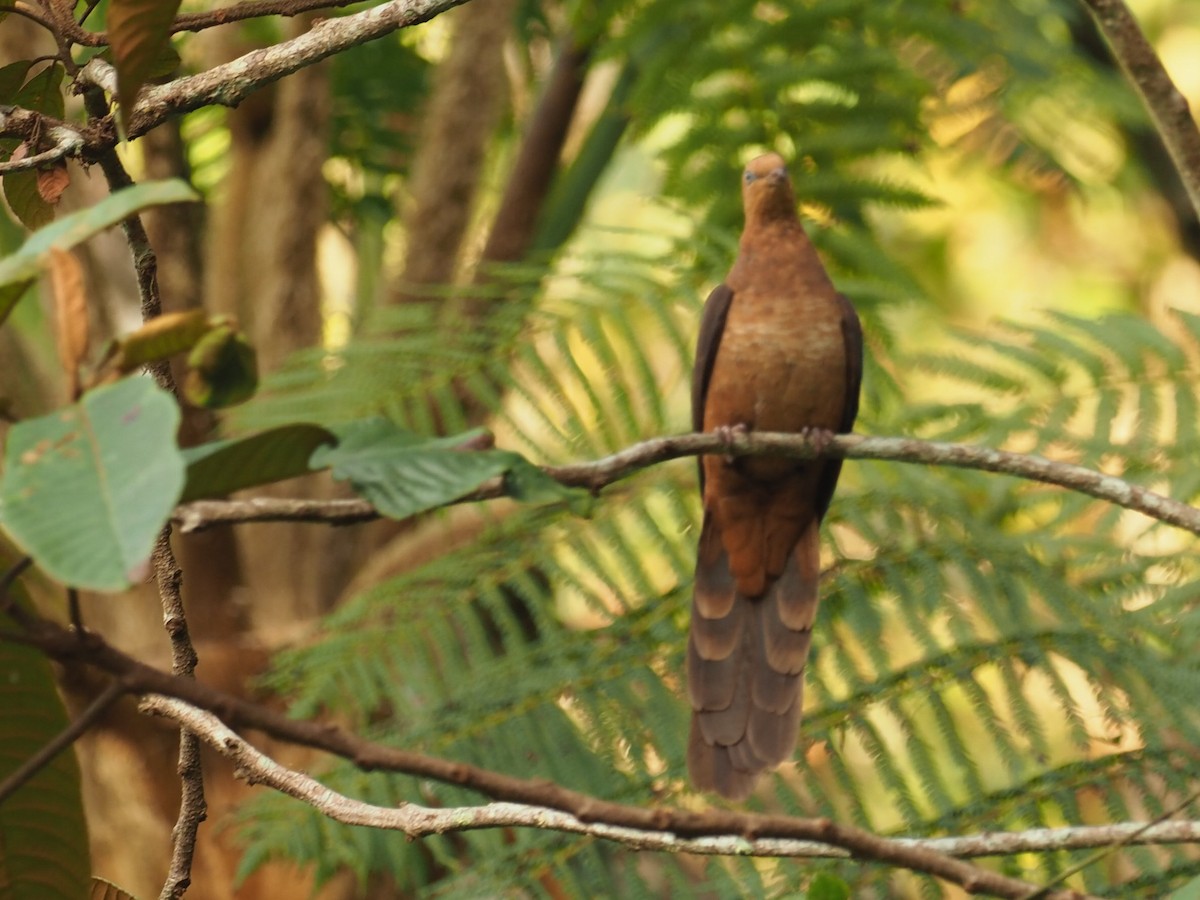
[312, 418, 572, 518]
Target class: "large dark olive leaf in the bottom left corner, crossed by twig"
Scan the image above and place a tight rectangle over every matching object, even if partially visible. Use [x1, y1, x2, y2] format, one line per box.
[0, 559, 91, 900]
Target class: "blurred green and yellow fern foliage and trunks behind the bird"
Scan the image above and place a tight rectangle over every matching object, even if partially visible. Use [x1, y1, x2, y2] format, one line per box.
[7, 0, 1200, 898]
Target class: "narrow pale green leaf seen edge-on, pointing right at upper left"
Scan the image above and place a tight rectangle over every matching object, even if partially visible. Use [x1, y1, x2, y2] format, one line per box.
[0, 179, 199, 323]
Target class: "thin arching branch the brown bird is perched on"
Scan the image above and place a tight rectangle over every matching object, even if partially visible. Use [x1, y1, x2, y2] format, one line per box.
[172, 432, 1200, 535]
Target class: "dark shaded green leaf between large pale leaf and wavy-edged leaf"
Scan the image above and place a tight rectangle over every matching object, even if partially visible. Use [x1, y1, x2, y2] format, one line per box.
[180, 425, 337, 503]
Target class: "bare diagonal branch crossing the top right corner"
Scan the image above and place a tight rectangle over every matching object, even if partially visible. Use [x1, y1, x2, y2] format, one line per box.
[1084, 0, 1200, 216]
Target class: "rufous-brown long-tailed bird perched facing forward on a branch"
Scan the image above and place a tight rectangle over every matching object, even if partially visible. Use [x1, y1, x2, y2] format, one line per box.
[688, 154, 863, 799]
